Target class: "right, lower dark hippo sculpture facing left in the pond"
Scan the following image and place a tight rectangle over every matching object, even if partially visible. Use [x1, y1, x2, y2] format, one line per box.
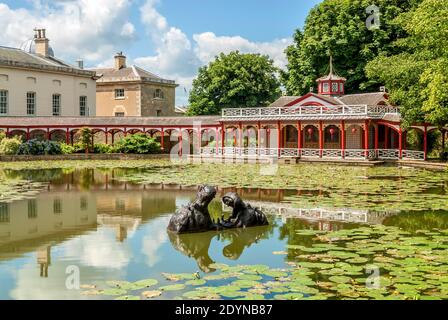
[219, 192, 269, 229]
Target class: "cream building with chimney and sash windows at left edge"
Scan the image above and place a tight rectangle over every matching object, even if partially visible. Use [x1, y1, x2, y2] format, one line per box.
[0, 29, 96, 117]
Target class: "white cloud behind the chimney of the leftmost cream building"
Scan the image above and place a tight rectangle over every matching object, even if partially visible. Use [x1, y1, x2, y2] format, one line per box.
[0, 0, 136, 62]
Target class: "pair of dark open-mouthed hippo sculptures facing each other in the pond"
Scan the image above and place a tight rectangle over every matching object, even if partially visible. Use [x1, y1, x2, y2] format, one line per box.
[168, 186, 269, 234]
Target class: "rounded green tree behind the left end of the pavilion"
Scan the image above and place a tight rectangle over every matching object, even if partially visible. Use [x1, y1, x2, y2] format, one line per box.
[187, 51, 281, 116]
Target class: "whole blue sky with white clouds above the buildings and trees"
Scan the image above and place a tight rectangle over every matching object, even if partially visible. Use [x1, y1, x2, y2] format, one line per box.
[0, 0, 320, 105]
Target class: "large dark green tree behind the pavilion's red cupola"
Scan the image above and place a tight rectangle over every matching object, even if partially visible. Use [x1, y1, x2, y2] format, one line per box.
[281, 0, 421, 95]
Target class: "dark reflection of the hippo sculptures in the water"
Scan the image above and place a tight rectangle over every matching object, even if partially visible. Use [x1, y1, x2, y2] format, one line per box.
[168, 225, 273, 273]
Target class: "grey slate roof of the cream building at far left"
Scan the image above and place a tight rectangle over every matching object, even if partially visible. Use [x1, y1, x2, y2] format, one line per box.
[0, 46, 95, 77]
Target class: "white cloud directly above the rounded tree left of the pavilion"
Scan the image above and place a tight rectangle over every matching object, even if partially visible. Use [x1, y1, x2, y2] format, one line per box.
[135, 0, 292, 105]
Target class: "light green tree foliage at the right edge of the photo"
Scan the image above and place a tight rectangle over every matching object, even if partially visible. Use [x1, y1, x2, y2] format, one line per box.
[366, 0, 448, 147]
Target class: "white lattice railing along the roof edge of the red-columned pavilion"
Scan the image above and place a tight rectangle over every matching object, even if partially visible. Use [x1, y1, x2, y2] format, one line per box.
[222, 105, 399, 119]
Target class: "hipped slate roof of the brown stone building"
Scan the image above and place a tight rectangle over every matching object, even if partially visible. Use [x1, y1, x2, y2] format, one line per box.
[93, 66, 175, 85]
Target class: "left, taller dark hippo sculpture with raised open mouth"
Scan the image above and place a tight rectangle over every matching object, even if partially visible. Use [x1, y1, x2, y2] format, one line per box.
[168, 186, 218, 233]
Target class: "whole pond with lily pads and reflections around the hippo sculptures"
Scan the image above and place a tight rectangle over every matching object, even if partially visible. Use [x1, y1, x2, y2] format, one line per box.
[0, 160, 448, 300]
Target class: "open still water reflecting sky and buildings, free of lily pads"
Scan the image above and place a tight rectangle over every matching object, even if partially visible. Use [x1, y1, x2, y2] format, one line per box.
[0, 169, 448, 299]
